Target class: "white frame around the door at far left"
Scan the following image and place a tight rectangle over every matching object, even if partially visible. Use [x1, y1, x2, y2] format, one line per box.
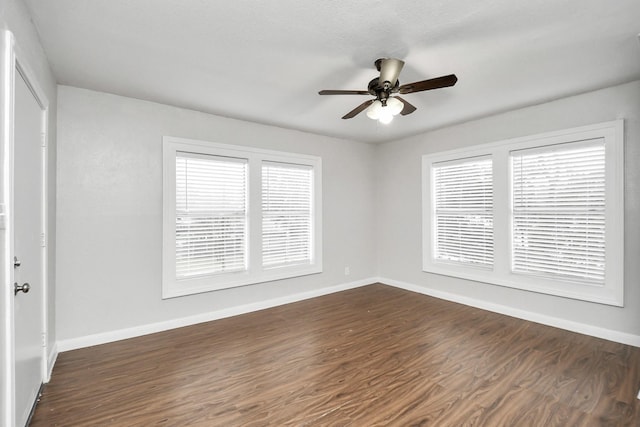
[0, 30, 50, 426]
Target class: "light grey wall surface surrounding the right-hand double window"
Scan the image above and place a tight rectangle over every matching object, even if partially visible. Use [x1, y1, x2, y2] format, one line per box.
[376, 81, 640, 345]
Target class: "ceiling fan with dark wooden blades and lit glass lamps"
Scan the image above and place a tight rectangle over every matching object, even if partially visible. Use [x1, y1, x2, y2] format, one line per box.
[318, 58, 458, 124]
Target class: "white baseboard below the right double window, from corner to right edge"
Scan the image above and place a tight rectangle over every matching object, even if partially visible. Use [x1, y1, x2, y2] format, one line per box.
[377, 277, 640, 347]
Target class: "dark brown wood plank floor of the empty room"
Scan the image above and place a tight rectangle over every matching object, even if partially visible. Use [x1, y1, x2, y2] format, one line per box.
[31, 285, 640, 427]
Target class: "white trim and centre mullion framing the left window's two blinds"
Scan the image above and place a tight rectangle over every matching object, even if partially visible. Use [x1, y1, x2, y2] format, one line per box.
[162, 136, 322, 299]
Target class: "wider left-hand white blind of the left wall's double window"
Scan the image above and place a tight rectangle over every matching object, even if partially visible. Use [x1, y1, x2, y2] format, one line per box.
[175, 153, 247, 279]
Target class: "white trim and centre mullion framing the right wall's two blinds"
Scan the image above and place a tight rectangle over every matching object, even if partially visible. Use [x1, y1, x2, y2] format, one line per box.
[422, 120, 624, 307]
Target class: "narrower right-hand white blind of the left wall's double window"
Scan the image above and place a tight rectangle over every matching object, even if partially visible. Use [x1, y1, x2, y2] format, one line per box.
[262, 161, 313, 268]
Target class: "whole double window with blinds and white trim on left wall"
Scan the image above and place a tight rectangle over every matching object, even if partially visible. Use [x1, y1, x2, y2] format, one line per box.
[163, 137, 322, 298]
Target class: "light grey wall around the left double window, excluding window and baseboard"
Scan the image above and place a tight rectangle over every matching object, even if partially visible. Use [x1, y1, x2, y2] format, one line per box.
[57, 86, 376, 348]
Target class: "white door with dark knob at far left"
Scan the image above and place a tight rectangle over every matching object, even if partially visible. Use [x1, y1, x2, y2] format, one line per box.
[13, 70, 44, 426]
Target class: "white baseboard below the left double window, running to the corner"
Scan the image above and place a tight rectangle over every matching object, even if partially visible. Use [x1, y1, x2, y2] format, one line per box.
[56, 278, 376, 354]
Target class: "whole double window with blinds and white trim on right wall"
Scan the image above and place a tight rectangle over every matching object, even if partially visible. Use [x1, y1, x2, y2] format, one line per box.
[423, 121, 624, 306]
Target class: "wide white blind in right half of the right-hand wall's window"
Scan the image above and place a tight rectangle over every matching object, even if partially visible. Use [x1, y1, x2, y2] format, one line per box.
[511, 139, 606, 284]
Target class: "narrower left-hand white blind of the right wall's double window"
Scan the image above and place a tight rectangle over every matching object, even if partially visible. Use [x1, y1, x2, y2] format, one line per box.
[433, 158, 493, 268]
